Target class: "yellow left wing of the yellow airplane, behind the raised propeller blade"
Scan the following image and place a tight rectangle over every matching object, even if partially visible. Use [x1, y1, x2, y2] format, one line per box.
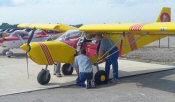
[18, 23, 77, 31]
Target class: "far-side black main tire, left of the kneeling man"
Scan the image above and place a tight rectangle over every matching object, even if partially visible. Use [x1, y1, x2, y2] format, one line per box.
[62, 63, 74, 75]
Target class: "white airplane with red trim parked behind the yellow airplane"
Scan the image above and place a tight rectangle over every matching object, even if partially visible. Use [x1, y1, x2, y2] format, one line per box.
[0, 29, 51, 57]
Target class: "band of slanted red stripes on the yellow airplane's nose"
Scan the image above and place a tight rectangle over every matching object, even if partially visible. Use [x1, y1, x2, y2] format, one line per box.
[38, 43, 54, 65]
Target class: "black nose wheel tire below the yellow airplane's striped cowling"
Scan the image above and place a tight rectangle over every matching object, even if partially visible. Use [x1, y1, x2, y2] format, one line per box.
[37, 69, 50, 85]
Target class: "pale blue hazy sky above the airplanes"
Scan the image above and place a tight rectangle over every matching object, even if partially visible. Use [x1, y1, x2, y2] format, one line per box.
[0, 0, 175, 24]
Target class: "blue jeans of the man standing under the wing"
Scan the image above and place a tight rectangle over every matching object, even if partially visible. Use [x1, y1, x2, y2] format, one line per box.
[105, 48, 119, 79]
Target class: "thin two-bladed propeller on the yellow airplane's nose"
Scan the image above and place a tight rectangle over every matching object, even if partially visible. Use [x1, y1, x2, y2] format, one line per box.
[26, 28, 36, 79]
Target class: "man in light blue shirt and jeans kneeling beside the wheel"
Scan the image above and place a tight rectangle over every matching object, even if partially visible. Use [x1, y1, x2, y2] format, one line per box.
[73, 50, 95, 89]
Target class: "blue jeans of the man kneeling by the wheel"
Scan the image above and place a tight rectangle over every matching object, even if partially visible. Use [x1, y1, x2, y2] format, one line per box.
[77, 73, 93, 87]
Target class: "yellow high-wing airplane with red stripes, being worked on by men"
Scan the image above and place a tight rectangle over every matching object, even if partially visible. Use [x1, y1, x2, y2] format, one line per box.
[18, 8, 175, 85]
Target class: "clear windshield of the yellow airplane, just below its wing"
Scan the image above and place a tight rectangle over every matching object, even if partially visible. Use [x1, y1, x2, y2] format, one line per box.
[56, 30, 83, 41]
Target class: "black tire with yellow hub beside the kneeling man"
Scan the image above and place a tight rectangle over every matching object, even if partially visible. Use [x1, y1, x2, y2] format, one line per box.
[95, 70, 108, 85]
